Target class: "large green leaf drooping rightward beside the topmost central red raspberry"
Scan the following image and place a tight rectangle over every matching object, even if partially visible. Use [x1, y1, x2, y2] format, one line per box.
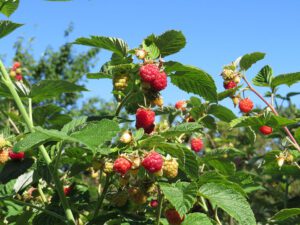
[165, 61, 218, 102]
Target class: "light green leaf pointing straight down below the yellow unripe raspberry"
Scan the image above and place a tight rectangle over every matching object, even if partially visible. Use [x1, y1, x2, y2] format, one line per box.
[159, 182, 198, 217]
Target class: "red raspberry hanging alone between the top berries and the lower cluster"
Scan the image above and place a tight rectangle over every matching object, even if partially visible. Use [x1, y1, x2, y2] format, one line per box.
[135, 108, 155, 130]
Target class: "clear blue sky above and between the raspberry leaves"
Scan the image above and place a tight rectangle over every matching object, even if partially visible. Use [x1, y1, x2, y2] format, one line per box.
[0, 0, 300, 112]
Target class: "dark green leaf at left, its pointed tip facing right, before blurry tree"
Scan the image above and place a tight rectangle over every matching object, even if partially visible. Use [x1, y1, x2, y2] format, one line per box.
[30, 80, 87, 102]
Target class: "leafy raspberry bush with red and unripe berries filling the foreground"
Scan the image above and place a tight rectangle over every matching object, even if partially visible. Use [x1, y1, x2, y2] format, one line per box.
[0, 1, 300, 225]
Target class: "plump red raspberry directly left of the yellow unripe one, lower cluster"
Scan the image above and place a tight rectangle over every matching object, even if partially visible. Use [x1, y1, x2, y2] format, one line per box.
[142, 151, 164, 173]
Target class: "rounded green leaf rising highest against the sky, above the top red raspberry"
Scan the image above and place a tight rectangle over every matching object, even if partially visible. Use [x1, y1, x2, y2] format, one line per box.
[145, 30, 186, 57]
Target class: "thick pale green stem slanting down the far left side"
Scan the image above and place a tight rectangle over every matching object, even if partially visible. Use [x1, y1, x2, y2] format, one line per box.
[0, 60, 75, 224]
